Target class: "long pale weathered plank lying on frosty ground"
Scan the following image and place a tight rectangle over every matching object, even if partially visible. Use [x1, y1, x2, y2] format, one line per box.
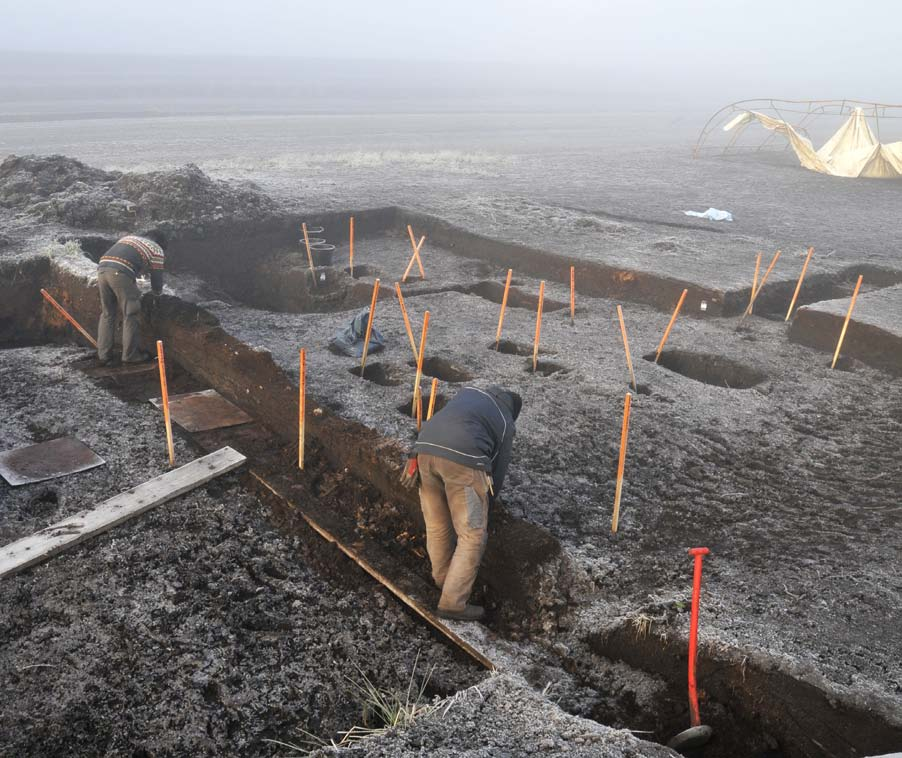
[0, 447, 247, 578]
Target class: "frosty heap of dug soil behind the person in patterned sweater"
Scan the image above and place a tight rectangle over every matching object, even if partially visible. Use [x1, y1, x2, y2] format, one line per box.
[0, 155, 277, 234]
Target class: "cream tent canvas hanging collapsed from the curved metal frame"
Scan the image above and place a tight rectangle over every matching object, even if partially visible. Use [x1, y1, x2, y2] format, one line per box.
[724, 108, 902, 179]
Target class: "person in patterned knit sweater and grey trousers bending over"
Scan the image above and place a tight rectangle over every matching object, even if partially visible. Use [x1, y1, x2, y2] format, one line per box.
[97, 231, 166, 365]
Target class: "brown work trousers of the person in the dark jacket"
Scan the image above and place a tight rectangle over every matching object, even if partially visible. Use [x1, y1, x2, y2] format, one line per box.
[417, 454, 490, 611]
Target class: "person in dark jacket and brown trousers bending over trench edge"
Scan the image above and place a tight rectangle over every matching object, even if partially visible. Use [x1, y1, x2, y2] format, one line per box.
[401, 387, 522, 621]
